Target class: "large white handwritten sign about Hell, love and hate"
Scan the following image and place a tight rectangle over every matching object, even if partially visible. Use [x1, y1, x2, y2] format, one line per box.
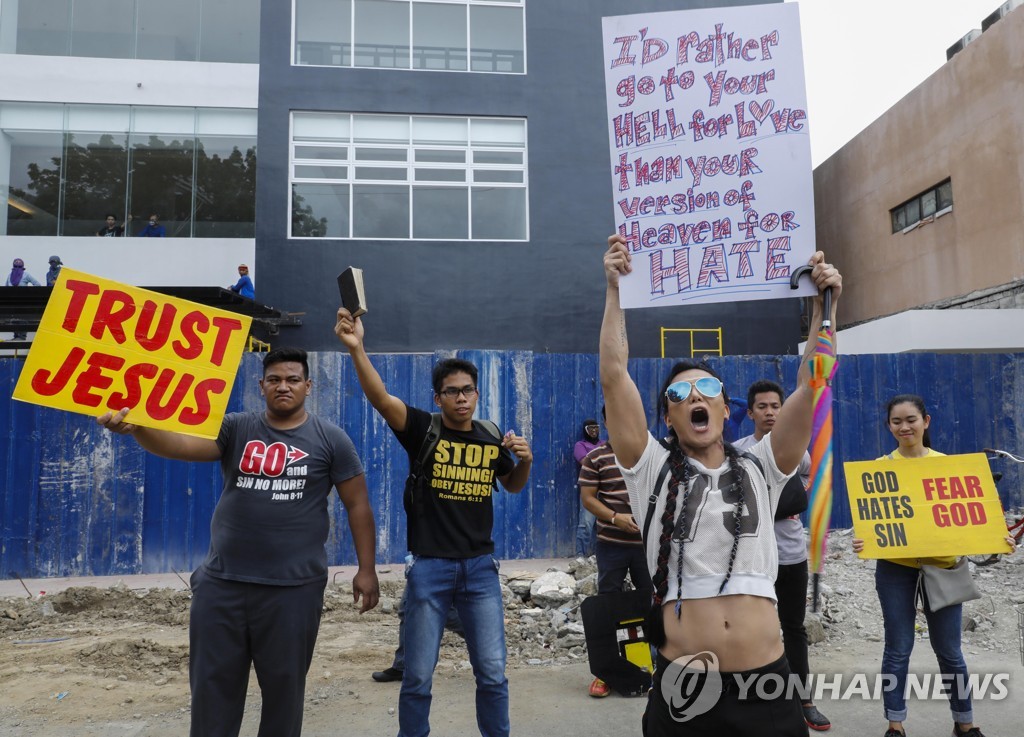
[603, 3, 815, 307]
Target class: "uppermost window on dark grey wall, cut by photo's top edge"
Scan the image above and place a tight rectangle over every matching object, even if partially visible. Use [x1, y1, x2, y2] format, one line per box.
[293, 0, 526, 74]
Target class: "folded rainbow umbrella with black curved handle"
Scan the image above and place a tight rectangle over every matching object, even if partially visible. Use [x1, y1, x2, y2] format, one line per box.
[790, 266, 837, 611]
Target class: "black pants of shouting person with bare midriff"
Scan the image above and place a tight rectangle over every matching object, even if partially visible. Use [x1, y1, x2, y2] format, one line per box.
[642, 653, 807, 737]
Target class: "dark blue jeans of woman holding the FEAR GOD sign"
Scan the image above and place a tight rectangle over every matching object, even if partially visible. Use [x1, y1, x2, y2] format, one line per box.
[874, 560, 974, 724]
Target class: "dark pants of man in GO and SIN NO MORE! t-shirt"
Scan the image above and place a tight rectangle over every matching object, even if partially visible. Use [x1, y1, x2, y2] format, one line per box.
[188, 568, 327, 737]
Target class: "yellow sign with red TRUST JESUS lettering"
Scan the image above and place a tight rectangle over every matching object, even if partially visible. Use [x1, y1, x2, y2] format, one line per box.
[14, 268, 252, 437]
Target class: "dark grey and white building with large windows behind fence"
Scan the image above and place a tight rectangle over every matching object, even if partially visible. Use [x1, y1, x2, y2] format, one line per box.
[0, 0, 813, 356]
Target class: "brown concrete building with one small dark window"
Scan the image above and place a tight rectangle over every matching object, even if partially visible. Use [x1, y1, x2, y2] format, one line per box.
[814, 1, 1024, 352]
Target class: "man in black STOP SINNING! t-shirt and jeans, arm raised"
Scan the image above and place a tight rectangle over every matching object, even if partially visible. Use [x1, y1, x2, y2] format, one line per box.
[334, 308, 534, 737]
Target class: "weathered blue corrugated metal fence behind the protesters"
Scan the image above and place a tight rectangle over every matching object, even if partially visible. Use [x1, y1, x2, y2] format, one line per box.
[0, 351, 1024, 578]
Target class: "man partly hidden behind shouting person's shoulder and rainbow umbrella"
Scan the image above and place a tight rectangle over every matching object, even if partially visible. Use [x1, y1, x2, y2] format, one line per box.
[733, 381, 831, 732]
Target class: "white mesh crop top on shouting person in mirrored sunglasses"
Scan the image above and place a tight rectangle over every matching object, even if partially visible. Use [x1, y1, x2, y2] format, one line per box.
[623, 433, 790, 602]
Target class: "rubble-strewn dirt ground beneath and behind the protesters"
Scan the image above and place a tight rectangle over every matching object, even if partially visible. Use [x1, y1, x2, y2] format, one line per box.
[0, 535, 1024, 737]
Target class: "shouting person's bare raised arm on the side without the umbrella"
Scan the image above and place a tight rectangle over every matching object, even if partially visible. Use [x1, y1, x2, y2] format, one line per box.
[599, 234, 647, 468]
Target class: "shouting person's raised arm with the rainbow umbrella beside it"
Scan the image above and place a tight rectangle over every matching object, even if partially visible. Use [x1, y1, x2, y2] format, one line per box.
[771, 251, 843, 473]
